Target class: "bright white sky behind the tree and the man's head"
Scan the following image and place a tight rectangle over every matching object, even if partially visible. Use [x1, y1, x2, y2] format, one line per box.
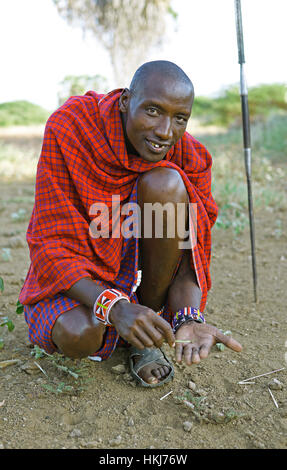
[0, 0, 287, 110]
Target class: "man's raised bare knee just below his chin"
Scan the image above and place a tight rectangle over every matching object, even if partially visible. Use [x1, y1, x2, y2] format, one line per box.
[138, 167, 188, 203]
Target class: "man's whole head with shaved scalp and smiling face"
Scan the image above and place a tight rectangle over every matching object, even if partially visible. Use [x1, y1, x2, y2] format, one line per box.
[119, 60, 194, 162]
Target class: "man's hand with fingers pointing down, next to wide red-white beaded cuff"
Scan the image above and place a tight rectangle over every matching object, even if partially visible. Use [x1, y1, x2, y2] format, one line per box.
[109, 300, 175, 349]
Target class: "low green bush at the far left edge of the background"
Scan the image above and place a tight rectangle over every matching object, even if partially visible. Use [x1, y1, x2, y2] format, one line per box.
[0, 100, 49, 127]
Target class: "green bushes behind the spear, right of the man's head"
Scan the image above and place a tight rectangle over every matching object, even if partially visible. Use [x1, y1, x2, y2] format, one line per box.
[192, 84, 287, 127]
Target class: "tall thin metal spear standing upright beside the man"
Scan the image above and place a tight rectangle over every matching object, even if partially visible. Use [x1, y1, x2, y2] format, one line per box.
[235, 0, 257, 302]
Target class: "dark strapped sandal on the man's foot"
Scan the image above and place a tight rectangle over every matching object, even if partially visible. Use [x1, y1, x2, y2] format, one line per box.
[129, 346, 174, 388]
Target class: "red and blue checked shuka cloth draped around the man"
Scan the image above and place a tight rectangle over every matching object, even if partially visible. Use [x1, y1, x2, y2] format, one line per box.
[19, 89, 217, 358]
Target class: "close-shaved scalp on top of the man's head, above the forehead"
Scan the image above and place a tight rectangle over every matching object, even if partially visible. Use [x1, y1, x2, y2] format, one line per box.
[129, 60, 194, 95]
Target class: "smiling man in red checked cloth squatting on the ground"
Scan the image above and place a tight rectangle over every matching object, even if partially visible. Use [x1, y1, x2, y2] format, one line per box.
[19, 61, 242, 386]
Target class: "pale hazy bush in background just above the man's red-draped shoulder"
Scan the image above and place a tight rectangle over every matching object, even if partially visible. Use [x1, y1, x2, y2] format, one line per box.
[58, 75, 107, 105]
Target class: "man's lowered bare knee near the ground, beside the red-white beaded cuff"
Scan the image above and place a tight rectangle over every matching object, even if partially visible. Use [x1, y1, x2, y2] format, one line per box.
[52, 306, 104, 359]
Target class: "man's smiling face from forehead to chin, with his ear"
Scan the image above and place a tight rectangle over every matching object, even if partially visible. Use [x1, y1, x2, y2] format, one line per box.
[119, 75, 193, 162]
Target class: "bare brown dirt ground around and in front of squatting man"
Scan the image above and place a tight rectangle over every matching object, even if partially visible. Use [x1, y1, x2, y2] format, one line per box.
[0, 130, 287, 449]
